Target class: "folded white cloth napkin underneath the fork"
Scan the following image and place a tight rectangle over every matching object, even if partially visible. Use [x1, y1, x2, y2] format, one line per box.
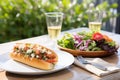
[74, 58, 120, 76]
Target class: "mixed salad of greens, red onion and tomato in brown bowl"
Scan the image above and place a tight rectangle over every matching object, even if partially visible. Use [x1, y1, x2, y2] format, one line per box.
[57, 32, 117, 52]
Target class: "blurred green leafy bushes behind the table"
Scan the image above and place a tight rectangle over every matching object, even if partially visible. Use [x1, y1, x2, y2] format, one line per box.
[0, 0, 117, 43]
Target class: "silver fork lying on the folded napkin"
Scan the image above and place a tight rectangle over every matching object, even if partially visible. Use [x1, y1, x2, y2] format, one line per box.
[76, 56, 107, 71]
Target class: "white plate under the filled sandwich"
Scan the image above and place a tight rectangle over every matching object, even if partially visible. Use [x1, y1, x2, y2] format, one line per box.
[0, 50, 74, 75]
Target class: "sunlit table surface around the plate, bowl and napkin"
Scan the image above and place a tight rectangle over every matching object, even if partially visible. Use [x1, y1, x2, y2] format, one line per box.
[0, 28, 120, 80]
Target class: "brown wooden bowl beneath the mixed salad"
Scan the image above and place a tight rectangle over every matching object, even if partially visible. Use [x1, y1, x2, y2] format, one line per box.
[58, 46, 114, 57]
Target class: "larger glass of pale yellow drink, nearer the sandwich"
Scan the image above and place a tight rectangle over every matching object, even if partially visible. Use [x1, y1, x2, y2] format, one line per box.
[45, 12, 63, 39]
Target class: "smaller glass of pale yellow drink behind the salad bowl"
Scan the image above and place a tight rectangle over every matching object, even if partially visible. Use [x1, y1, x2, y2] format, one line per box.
[88, 10, 102, 32]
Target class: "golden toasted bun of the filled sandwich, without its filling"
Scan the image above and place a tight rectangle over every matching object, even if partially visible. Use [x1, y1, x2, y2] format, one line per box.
[10, 43, 58, 70]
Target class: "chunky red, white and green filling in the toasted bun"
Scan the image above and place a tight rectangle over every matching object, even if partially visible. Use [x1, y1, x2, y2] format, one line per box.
[13, 43, 57, 64]
